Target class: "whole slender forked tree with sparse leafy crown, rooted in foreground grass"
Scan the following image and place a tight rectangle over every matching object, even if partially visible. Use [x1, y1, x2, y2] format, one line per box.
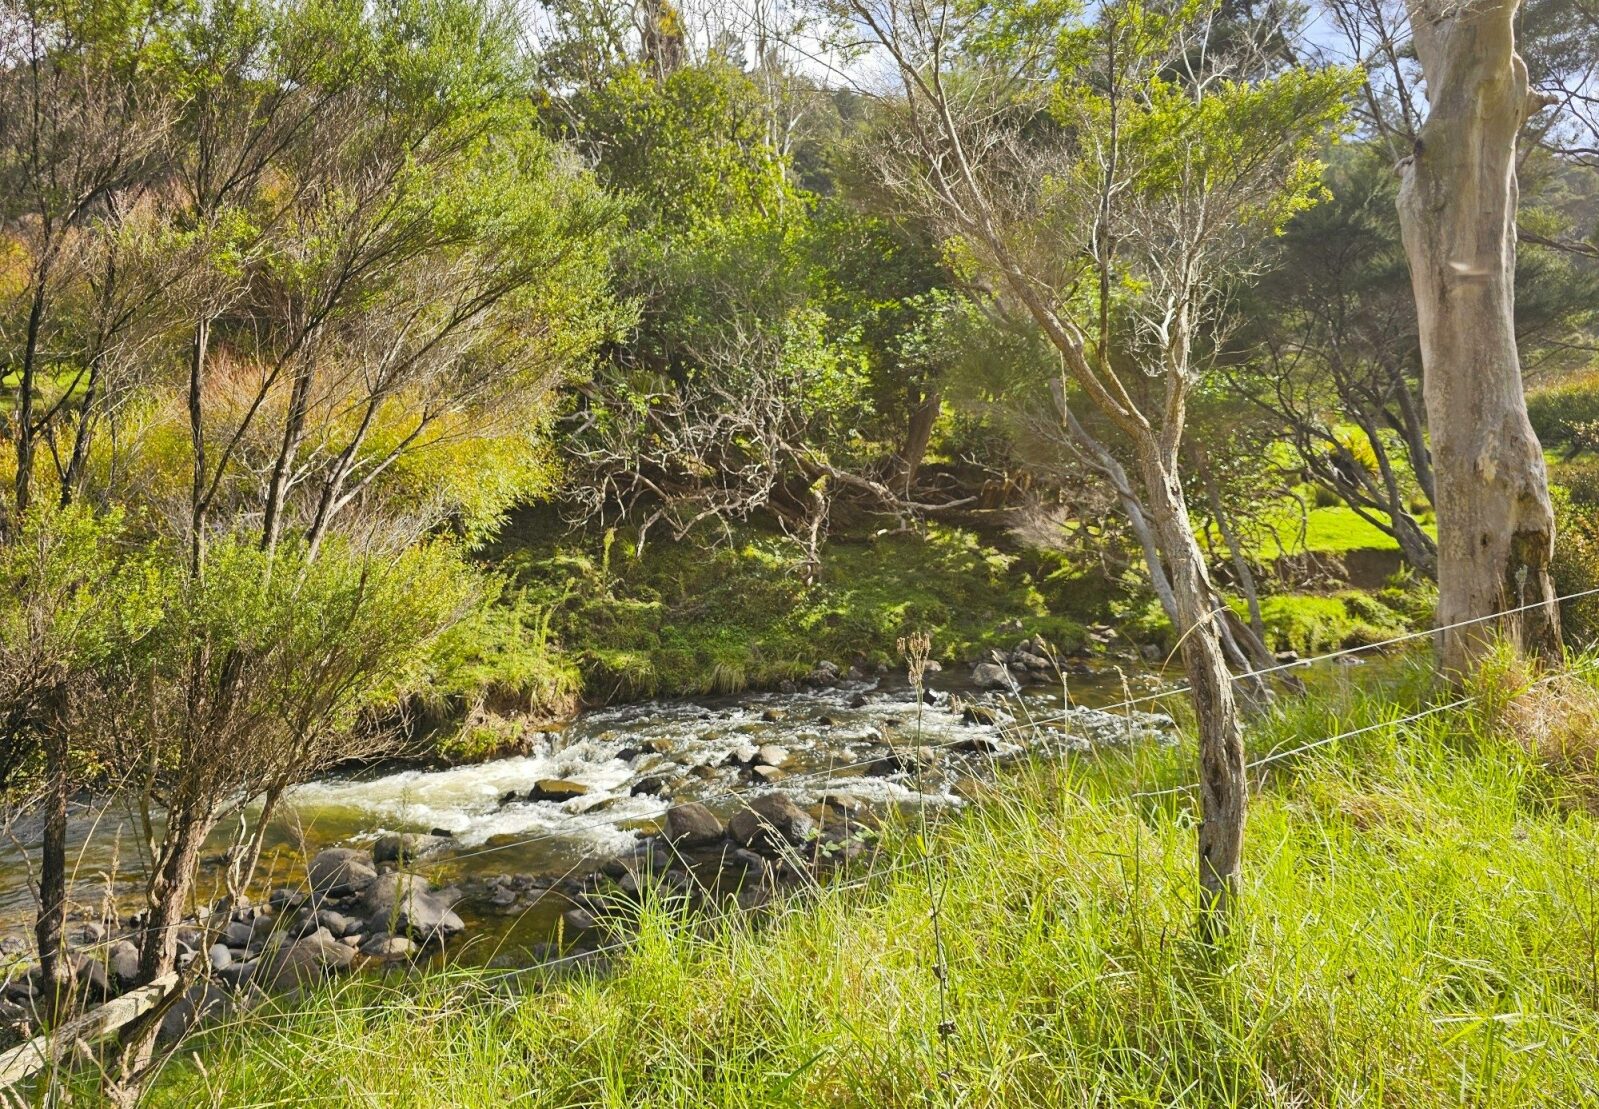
[849, 0, 1351, 932]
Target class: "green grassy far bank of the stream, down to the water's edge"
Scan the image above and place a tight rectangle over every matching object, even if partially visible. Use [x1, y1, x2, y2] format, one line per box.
[421, 510, 1433, 762]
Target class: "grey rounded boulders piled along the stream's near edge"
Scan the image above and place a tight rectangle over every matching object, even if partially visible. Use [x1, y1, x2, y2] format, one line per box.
[0, 794, 870, 1043]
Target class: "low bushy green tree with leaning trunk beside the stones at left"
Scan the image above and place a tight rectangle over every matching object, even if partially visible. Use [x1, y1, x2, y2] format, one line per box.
[85, 535, 475, 1104]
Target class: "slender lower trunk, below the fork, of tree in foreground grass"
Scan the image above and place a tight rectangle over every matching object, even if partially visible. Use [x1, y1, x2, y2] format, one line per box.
[1138, 438, 1247, 936]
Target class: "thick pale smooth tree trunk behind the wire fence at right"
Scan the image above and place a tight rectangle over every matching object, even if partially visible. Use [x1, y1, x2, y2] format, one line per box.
[1399, 0, 1559, 678]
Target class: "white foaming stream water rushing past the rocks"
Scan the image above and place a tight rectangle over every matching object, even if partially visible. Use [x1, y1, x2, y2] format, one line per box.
[0, 670, 1196, 962]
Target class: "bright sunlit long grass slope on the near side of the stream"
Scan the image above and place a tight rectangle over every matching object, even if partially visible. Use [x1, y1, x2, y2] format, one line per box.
[157, 664, 1599, 1107]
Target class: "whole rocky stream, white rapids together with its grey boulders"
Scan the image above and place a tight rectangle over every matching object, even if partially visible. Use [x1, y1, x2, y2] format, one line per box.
[0, 667, 1172, 1050]
